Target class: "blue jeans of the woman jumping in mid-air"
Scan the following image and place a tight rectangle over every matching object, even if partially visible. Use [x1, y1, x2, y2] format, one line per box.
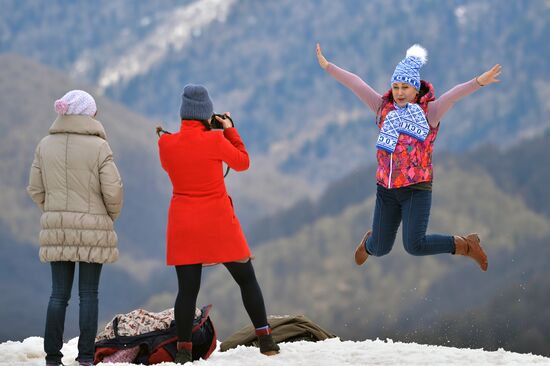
[365, 186, 455, 257]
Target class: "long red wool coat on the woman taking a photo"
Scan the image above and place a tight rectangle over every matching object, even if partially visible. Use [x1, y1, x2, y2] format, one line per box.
[159, 121, 250, 265]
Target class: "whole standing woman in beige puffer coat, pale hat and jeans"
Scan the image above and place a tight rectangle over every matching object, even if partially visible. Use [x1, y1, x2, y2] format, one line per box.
[27, 90, 123, 365]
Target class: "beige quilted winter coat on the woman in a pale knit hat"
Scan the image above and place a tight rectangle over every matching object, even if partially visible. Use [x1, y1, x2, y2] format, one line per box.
[27, 115, 123, 263]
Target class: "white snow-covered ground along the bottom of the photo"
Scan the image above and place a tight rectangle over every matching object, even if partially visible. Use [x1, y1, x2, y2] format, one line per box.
[0, 337, 550, 366]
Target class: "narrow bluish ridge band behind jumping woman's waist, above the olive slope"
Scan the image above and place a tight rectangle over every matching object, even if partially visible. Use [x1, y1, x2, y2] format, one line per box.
[248, 128, 550, 244]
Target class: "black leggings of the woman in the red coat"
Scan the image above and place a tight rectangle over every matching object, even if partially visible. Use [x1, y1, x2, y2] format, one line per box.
[174, 260, 268, 342]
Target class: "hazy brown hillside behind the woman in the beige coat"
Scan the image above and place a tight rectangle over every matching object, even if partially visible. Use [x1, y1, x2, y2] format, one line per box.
[0, 55, 170, 254]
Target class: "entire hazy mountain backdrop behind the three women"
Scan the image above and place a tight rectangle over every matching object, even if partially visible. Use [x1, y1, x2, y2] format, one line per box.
[0, 0, 550, 353]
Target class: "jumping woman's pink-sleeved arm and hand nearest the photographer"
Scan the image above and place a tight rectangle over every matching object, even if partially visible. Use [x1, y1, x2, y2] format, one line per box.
[316, 43, 382, 113]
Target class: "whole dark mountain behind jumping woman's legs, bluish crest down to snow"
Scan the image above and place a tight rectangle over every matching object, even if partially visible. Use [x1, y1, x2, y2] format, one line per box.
[158, 129, 550, 355]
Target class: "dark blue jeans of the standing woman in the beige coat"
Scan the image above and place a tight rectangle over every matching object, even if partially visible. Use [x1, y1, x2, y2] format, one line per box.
[44, 262, 102, 363]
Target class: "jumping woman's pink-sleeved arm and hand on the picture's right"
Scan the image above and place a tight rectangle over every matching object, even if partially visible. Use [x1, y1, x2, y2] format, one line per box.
[427, 64, 502, 127]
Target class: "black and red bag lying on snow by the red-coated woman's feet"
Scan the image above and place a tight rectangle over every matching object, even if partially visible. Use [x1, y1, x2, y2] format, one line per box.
[94, 305, 217, 365]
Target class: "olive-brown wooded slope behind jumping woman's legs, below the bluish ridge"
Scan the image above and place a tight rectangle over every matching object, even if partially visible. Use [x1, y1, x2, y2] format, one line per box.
[144, 163, 550, 352]
